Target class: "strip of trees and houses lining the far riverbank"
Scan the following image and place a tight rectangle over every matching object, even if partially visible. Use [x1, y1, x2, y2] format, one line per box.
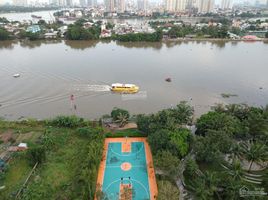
[0, 18, 268, 42]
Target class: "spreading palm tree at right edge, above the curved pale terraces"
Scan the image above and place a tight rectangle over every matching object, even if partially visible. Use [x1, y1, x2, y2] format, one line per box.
[242, 142, 268, 171]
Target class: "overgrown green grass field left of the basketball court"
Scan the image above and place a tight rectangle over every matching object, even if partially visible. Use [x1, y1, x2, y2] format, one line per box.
[0, 122, 101, 200]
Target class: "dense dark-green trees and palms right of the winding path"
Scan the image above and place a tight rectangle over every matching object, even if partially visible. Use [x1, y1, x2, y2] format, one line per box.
[187, 104, 268, 199]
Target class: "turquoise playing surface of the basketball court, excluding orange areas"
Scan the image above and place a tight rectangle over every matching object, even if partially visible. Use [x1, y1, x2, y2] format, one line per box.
[102, 142, 150, 200]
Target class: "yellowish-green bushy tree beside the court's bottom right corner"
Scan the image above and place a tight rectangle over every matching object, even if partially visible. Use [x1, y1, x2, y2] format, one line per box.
[157, 180, 180, 200]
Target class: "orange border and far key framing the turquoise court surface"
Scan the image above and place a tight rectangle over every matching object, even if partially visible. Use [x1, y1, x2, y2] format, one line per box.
[95, 137, 158, 200]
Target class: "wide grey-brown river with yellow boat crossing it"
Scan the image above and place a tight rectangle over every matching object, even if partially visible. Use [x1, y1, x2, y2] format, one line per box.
[0, 41, 268, 119]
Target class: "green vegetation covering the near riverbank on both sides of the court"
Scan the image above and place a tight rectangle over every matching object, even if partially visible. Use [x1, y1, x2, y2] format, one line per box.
[0, 102, 268, 200]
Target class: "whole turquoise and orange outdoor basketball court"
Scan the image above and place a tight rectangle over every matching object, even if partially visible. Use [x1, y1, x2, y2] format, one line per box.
[97, 138, 157, 200]
